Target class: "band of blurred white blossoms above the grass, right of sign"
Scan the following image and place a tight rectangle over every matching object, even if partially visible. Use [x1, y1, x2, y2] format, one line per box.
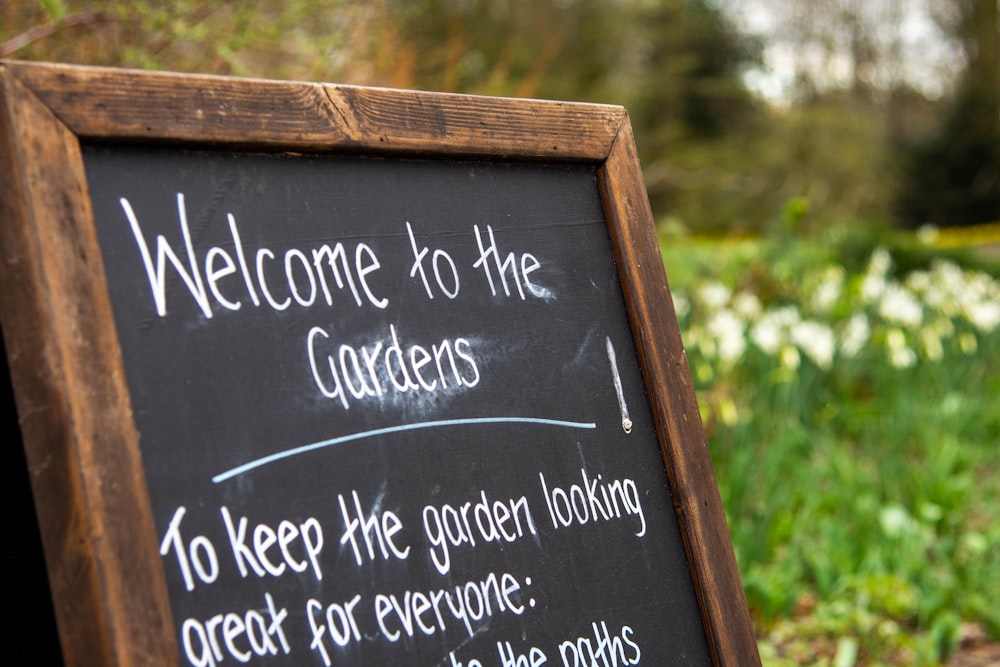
[673, 248, 1000, 380]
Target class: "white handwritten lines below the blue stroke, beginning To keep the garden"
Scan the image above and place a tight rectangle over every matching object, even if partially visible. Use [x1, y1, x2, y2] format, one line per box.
[160, 468, 647, 666]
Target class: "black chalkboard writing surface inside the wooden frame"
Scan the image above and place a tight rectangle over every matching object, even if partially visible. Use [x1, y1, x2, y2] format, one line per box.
[84, 149, 710, 665]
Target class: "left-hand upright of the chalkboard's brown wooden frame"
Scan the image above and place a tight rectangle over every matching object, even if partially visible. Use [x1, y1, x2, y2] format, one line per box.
[0, 65, 177, 665]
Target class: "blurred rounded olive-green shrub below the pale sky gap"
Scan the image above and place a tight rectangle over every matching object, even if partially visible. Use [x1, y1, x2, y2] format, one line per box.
[644, 94, 899, 235]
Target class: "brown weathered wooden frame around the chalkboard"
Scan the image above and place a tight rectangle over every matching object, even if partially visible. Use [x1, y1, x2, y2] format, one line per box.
[0, 62, 760, 665]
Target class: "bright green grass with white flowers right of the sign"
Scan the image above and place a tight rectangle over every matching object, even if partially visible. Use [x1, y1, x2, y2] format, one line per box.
[663, 226, 1000, 667]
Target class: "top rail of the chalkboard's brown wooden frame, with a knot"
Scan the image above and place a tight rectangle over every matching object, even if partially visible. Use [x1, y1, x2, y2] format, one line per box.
[8, 62, 625, 160]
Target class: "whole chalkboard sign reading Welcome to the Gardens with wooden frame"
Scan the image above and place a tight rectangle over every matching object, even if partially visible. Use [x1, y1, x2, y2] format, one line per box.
[0, 63, 759, 667]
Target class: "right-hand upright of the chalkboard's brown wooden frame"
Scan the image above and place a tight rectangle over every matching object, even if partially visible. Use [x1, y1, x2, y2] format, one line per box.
[601, 122, 760, 667]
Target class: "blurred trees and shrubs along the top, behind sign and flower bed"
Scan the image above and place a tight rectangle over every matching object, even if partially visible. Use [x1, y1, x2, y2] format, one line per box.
[0, 0, 1000, 234]
